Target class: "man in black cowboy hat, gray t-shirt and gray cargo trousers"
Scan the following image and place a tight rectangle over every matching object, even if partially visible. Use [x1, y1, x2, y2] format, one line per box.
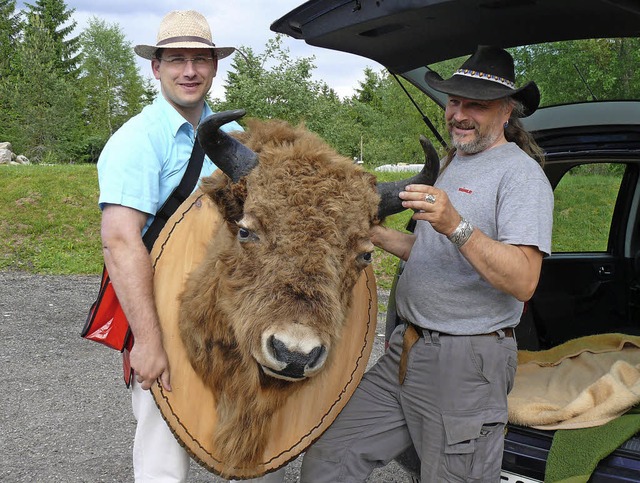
[301, 46, 553, 483]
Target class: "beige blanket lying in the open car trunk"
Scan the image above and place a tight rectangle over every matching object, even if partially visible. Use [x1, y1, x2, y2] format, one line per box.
[509, 334, 640, 429]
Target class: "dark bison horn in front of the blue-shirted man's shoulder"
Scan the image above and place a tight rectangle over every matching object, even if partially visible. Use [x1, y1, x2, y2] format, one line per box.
[198, 109, 258, 183]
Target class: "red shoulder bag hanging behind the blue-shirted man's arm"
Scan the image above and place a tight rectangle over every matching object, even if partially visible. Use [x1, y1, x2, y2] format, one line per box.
[80, 267, 133, 352]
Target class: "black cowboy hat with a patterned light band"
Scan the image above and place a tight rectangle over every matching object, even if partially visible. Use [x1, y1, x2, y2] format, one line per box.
[424, 45, 540, 117]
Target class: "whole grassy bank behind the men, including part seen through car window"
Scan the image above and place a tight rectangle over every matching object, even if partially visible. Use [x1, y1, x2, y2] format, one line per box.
[0, 164, 620, 288]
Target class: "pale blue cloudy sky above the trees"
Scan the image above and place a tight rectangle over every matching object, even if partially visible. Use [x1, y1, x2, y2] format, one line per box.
[16, 0, 382, 98]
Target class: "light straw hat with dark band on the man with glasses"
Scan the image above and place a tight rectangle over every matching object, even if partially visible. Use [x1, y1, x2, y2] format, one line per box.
[133, 10, 236, 60]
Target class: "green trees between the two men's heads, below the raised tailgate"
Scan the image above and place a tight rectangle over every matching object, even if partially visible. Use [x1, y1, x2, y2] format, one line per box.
[213, 36, 442, 168]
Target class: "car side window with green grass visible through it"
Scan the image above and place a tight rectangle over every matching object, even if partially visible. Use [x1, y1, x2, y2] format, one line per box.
[552, 163, 624, 253]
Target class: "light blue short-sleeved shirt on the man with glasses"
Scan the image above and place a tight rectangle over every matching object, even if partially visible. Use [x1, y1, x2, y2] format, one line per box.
[98, 95, 242, 231]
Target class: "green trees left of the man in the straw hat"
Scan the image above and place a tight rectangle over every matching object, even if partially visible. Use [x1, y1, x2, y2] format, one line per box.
[0, 0, 156, 163]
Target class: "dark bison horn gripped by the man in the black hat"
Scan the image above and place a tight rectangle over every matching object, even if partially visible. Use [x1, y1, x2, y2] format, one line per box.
[378, 135, 440, 220]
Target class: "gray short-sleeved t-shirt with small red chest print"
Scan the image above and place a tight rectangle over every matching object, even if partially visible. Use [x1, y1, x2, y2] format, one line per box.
[396, 143, 553, 335]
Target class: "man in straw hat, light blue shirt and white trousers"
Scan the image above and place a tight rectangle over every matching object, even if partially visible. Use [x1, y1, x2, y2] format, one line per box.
[98, 10, 278, 483]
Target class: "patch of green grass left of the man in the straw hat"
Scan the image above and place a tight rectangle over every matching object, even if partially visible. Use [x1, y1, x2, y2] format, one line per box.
[0, 165, 102, 274]
